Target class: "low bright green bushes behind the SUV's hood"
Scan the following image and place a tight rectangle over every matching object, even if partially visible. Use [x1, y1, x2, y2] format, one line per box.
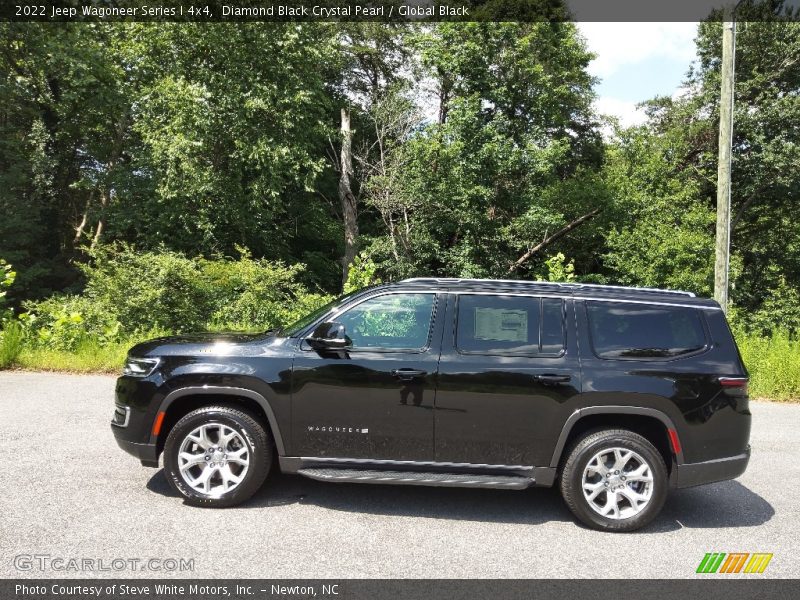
[15, 246, 331, 350]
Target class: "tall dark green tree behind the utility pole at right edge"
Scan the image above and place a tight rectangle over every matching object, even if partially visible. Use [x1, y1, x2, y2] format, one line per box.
[689, 9, 800, 325]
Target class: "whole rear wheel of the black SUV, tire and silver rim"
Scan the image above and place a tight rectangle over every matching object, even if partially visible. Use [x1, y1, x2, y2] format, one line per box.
[561, 429, 668, 531]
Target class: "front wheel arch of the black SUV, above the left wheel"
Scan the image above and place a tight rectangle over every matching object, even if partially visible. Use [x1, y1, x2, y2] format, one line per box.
[151, 385, 286, 456]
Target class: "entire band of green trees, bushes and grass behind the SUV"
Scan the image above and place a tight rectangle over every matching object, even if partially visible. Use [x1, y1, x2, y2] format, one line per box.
[0, 10, 800, 399]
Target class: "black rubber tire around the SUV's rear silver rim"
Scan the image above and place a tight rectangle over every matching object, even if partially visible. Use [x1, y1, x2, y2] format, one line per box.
[561, 429, 669, 532]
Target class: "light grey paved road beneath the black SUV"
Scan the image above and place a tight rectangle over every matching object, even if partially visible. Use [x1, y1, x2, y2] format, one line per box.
[0, 372, 800, 578]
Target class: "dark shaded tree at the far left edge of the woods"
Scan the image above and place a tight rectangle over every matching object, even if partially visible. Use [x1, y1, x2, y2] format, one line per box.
[0, 23, 129, 298]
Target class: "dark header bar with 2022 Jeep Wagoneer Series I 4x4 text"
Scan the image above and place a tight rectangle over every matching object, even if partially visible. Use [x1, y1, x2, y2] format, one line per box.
[0, 0, 800, 23]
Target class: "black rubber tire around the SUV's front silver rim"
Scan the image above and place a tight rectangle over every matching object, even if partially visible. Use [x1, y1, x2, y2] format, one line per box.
[164, 406, 273, 508]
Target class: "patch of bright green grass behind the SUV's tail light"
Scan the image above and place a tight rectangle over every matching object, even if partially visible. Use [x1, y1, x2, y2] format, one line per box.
[736, 334, 800, 402]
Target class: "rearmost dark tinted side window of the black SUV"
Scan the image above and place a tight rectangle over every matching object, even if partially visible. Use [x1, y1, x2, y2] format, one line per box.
[586, 302, 706, 360]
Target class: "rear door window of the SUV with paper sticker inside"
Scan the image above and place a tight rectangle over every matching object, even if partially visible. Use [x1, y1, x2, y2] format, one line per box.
[456, 294, 564, 355]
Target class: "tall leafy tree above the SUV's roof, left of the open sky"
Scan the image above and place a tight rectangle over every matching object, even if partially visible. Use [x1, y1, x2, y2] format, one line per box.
[364, 23, 603, 277]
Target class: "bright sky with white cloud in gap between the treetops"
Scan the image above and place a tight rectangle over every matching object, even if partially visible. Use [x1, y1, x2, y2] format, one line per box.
[578, 23, 697, 126]
